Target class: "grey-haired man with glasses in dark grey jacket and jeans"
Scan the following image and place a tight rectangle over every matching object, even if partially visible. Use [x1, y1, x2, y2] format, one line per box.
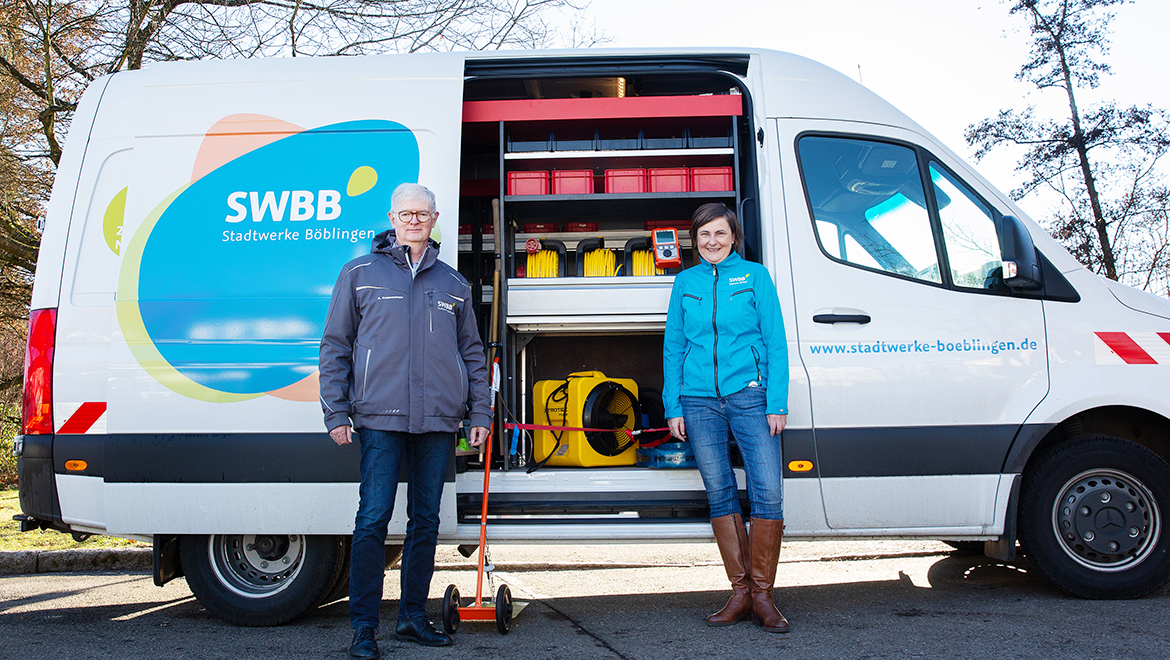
[319, 184, 491, 658]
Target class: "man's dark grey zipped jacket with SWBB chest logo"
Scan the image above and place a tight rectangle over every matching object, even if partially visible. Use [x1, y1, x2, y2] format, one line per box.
[319, 229, 491, 433]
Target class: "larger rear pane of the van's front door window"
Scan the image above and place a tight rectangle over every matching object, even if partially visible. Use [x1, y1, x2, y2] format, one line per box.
[798, 137, 942, 283]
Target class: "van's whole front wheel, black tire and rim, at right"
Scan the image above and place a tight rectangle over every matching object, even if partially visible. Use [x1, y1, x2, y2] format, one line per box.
[1019, 435, 1170, 599]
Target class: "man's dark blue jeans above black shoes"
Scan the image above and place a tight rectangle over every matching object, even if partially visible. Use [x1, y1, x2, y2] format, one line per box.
[350, 428, 454, 630]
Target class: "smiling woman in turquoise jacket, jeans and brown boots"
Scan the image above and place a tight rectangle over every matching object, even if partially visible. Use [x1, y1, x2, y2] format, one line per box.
[662, 204, 789, 633]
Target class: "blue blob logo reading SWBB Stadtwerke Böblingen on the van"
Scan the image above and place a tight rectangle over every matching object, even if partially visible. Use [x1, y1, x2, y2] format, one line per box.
[117, 119, 419, 401]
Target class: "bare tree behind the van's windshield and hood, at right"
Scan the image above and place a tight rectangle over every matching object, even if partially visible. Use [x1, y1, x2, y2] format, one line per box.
[965, 0, 1170, 293]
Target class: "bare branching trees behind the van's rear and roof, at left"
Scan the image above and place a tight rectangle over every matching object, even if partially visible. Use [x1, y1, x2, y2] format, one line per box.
[0, 0, 604, 417]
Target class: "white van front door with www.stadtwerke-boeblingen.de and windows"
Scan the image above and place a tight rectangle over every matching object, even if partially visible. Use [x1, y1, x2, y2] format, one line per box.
[778, 121, 1048, 534]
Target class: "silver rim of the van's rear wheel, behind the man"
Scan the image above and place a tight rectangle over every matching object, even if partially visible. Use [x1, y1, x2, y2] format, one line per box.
[207, 534, 304, 598]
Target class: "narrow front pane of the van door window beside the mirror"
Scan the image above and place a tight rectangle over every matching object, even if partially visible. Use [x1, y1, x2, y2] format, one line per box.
[930, 163, 1003, 289]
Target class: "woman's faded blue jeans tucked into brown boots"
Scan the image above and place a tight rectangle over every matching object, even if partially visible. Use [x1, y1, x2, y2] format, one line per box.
[681, 387, 784, 521]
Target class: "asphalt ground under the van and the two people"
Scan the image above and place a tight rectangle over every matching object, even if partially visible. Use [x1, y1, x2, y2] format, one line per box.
[0, 542, 1170, 660]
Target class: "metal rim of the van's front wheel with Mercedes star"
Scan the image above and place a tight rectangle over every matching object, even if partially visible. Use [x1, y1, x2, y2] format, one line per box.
[1052, 469, 1162, 572]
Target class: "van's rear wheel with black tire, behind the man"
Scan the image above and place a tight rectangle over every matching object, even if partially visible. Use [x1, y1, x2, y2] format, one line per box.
[180, 534, 344, 626]
